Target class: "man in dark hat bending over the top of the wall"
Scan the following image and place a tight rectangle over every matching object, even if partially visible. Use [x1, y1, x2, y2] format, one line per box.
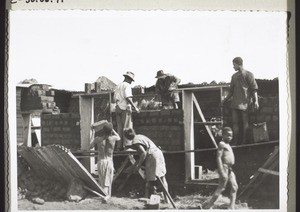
[155, 70, 181, 109]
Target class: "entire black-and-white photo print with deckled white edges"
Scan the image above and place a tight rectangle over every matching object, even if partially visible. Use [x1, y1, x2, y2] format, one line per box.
[8, 1, 289, 211]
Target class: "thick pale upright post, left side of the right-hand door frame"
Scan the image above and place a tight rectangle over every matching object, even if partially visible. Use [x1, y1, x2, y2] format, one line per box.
[182, 91, 195, 181]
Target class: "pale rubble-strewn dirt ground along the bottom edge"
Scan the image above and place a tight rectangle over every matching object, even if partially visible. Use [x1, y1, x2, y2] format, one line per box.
[18, 193, 248, 210]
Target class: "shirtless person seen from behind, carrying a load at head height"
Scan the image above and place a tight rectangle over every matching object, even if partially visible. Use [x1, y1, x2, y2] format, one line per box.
[90, 122, 120, 197]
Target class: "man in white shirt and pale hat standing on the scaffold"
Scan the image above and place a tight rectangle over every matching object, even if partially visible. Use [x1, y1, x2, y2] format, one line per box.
[114, 71, 139, 150]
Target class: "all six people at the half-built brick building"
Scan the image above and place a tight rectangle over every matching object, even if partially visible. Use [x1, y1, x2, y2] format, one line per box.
[90, 57, 259, 209]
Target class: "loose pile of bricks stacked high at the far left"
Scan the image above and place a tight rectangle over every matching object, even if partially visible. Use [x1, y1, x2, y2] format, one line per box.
[21, 84, 56, 112]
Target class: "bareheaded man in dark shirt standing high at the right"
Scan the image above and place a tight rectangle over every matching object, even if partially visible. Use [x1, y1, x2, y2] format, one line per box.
[222, 57, 259, 144]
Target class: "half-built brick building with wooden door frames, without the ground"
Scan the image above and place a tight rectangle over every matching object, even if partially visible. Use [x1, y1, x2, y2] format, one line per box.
[16, 77, 279, 208]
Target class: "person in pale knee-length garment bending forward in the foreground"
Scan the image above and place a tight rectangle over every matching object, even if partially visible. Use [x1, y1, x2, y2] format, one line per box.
[124, 128, 168, 201]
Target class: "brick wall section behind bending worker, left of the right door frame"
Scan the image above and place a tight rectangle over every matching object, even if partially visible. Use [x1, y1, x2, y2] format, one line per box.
[133, 110, 184, 151]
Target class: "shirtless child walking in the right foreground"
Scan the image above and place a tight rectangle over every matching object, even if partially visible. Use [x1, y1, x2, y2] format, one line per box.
[203, 127, 238, 209]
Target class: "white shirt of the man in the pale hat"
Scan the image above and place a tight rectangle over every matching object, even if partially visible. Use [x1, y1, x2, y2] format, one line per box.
[114, 82, 132, 110]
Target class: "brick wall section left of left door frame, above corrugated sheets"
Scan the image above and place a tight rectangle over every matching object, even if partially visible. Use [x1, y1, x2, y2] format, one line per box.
[41, 113, 80, 149]
